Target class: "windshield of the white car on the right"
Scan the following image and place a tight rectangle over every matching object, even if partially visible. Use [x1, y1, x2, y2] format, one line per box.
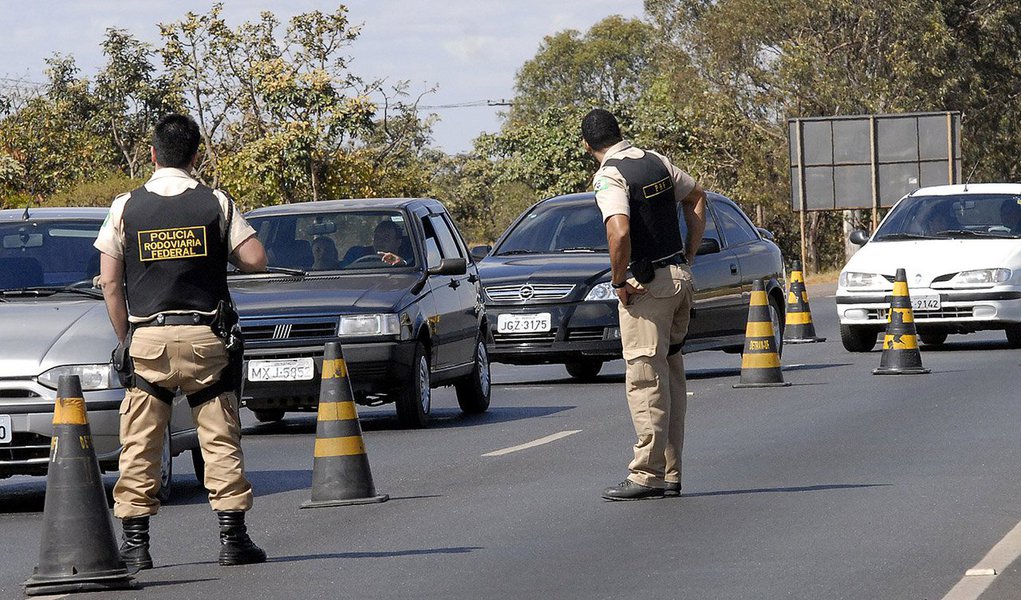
[874, 194, 1021, 241]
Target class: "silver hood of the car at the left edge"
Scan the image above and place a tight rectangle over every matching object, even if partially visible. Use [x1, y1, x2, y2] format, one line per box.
[0, 298, 117, 378]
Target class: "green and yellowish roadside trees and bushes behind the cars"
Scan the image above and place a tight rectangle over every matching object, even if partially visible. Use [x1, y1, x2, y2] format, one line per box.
[0, 0, 1021, 272]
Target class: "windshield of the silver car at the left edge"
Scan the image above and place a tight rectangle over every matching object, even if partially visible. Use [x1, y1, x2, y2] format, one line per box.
[0, 218, 103, 292]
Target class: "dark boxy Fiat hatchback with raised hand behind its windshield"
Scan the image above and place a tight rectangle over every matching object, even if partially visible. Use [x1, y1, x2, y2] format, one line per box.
[230, 199, 490, 428]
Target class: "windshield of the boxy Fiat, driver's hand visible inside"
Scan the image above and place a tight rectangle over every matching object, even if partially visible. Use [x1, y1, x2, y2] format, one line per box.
[248, 210, 418, 272]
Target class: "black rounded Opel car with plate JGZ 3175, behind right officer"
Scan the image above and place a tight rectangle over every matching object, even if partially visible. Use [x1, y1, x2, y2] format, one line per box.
[474, 192, 785, 379]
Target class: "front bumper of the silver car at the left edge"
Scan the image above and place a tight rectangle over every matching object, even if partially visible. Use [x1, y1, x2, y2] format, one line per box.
[0, 379, 125, 477]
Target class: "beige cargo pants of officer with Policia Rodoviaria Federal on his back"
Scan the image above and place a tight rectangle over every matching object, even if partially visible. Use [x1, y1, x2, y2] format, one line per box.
[113, 326, 252, 518]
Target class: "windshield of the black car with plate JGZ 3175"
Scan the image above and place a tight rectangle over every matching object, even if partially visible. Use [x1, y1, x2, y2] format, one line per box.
[493, 202, 607, 256]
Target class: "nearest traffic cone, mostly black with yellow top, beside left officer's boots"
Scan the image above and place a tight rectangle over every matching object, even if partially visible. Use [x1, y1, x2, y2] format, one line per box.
[23, 376, 136, 596]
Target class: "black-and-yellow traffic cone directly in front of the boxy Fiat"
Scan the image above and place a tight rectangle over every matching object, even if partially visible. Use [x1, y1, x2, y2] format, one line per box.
[301, 342, 390, 508]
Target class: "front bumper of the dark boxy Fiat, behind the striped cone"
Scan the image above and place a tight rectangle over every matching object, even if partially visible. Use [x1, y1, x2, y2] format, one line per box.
[242, 340, 416, 410]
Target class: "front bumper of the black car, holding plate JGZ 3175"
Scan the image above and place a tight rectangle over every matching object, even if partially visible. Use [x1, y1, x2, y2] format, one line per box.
[486, 299, 621, 364]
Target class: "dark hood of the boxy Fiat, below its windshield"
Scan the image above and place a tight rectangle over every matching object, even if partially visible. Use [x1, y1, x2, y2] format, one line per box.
[230, 272, 422, 317]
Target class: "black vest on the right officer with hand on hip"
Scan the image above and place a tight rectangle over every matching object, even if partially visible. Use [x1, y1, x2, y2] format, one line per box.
[602, 152, 684, 262]
